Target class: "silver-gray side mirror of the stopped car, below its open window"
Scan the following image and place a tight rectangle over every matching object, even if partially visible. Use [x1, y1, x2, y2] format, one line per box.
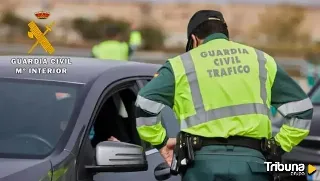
[85, 141, 148, 173]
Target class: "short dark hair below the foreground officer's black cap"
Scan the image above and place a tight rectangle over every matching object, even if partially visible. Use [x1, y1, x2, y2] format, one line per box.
[192, 20, 229, 39]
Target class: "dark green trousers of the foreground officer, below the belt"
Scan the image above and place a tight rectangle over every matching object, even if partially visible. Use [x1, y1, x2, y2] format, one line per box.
[182, 145, 270, 181]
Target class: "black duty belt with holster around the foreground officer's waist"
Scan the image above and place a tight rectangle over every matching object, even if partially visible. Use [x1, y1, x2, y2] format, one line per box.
[170, 131, 284, 181]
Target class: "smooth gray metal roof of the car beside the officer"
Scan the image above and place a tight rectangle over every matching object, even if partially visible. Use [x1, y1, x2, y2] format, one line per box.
[0, 56, 160, 84]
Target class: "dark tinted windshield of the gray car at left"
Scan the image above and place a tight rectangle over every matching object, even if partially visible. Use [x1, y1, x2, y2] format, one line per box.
[0, 79, 77, 158]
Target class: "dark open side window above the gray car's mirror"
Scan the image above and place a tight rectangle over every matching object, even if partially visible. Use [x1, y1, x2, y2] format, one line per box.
[89, 86, 157, 151]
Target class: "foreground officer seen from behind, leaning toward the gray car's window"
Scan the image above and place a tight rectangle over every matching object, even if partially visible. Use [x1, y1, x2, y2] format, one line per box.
[136, 10, 313, 181]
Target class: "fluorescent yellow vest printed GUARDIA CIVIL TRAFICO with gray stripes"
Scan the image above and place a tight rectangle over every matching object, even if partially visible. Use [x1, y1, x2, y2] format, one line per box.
[169, 39, 276, 138]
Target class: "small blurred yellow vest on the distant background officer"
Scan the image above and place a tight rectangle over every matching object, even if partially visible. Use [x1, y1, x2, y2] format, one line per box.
[92, 41, 129, 60]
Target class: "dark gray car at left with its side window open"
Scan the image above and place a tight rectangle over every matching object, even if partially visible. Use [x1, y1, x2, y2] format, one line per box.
[0, 56, 180, 181]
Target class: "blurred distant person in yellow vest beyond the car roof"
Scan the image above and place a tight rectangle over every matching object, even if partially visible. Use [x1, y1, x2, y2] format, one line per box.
[92, 26, 132, 61]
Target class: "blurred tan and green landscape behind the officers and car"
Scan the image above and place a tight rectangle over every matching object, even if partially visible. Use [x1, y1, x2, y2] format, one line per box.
[0, 0, 320, 91]
